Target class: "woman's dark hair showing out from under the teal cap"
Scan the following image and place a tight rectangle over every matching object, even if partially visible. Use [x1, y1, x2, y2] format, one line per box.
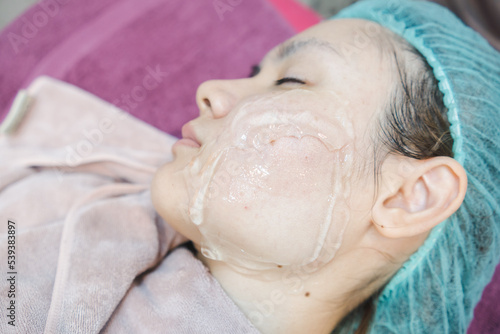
[348, 33, 453, 334]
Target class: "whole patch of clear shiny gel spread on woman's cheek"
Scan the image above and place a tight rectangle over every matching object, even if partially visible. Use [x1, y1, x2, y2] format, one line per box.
[178, 90, 354, 270]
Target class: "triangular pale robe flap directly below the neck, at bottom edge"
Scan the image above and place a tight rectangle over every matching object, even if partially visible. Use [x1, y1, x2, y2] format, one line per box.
[103, 248, 260, 334]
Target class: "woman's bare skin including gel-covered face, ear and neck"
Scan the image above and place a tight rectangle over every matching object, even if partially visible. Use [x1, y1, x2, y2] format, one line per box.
[152, 19, 467, 333]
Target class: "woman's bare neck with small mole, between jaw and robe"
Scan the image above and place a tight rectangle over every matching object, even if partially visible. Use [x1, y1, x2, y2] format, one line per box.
[193, 250, 348, 334]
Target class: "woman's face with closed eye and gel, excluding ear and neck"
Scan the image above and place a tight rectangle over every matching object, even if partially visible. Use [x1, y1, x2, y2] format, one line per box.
[152, 20, 393, 270]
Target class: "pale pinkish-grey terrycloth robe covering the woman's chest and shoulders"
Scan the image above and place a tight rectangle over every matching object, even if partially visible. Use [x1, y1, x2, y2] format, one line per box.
[0, 78, 257, 334]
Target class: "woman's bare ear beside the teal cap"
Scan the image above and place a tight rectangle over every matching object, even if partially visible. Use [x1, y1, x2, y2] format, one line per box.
[372, 157, 467, 238]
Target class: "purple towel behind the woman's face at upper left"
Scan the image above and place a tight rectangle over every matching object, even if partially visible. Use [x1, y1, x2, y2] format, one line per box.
[0, 0, 295, 137]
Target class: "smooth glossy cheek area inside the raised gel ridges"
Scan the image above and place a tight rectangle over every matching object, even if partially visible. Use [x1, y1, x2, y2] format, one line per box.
[199, 136, 350, 268]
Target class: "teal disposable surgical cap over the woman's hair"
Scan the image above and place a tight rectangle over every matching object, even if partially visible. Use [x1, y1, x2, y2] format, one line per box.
[334, 0, 500, 334]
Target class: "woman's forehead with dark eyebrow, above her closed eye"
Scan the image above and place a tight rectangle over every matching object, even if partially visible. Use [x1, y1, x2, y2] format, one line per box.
[261, 19, 397, 88]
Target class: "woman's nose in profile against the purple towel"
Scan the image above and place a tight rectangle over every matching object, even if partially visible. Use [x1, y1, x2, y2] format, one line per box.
[196, 80, 243, 118]
